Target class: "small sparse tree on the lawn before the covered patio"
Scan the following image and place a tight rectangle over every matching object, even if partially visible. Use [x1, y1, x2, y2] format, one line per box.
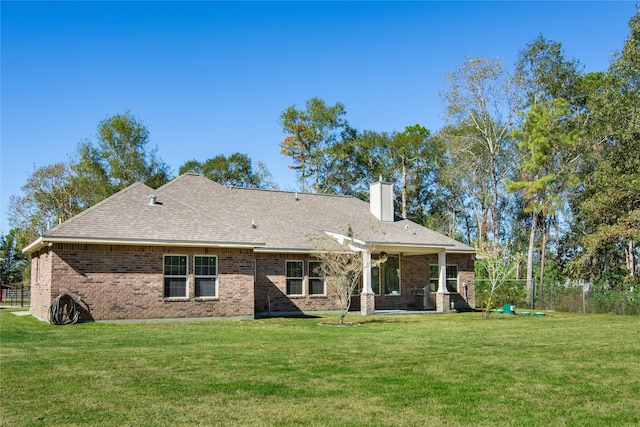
[312, 232, 367, 325]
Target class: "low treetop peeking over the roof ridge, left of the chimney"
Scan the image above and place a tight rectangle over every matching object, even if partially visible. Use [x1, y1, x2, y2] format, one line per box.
[179, 153, 276, 188]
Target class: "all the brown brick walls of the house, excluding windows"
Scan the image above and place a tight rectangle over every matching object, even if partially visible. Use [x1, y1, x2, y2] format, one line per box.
[31, 243, 475, 320]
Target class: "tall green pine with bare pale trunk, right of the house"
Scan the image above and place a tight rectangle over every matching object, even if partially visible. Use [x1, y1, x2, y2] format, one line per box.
[510, 35, 589, 305]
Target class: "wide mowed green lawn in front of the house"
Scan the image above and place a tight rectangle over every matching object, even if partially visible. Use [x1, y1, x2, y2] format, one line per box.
[0, 310, 640, 426]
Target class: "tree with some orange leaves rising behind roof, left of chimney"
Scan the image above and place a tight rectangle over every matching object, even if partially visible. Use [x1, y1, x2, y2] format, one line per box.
[280, 97, 348, 192]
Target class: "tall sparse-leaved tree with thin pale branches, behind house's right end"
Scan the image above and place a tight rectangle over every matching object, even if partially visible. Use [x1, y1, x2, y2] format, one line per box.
[441, 58, 520, 244]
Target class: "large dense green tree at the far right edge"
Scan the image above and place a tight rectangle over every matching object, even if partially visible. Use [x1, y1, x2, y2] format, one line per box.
[573, 12, 640, 289]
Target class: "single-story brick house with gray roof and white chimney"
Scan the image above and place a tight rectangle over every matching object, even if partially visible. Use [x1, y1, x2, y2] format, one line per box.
[24, 174, 475, 320]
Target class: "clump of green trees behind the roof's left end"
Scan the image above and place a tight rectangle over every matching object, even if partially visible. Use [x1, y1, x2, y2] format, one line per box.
[9, 112, 169, 247]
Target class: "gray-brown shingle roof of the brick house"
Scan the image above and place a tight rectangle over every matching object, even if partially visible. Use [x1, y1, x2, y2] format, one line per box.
[26, 174, 473, 252]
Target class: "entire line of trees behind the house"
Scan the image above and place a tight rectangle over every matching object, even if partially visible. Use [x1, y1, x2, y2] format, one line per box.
[3, 13, 640, 312]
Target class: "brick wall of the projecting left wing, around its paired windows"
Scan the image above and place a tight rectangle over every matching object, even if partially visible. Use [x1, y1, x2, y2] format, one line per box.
[38, 244, 254, 320]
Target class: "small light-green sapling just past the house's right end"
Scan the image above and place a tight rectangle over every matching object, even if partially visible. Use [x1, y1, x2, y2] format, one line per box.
[477, 243, 518, 319]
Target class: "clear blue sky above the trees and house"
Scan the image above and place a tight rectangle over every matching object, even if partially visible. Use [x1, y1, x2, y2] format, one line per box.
[0, 1, 636, 233]
